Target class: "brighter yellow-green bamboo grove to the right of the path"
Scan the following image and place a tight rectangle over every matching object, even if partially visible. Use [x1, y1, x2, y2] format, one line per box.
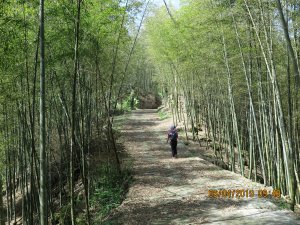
[143, 0, 300, 209]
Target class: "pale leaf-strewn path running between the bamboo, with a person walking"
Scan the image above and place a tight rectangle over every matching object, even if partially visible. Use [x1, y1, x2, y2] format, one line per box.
[107, 110, 300, 225]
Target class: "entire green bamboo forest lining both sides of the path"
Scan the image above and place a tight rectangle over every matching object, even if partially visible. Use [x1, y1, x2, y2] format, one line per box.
[0, 0, 300, 225]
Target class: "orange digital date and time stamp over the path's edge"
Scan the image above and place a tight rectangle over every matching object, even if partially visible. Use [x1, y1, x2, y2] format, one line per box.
[208, 189, 281, 199]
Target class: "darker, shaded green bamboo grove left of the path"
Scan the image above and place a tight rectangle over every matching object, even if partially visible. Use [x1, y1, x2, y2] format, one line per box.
[0, 0, 154, 225]
